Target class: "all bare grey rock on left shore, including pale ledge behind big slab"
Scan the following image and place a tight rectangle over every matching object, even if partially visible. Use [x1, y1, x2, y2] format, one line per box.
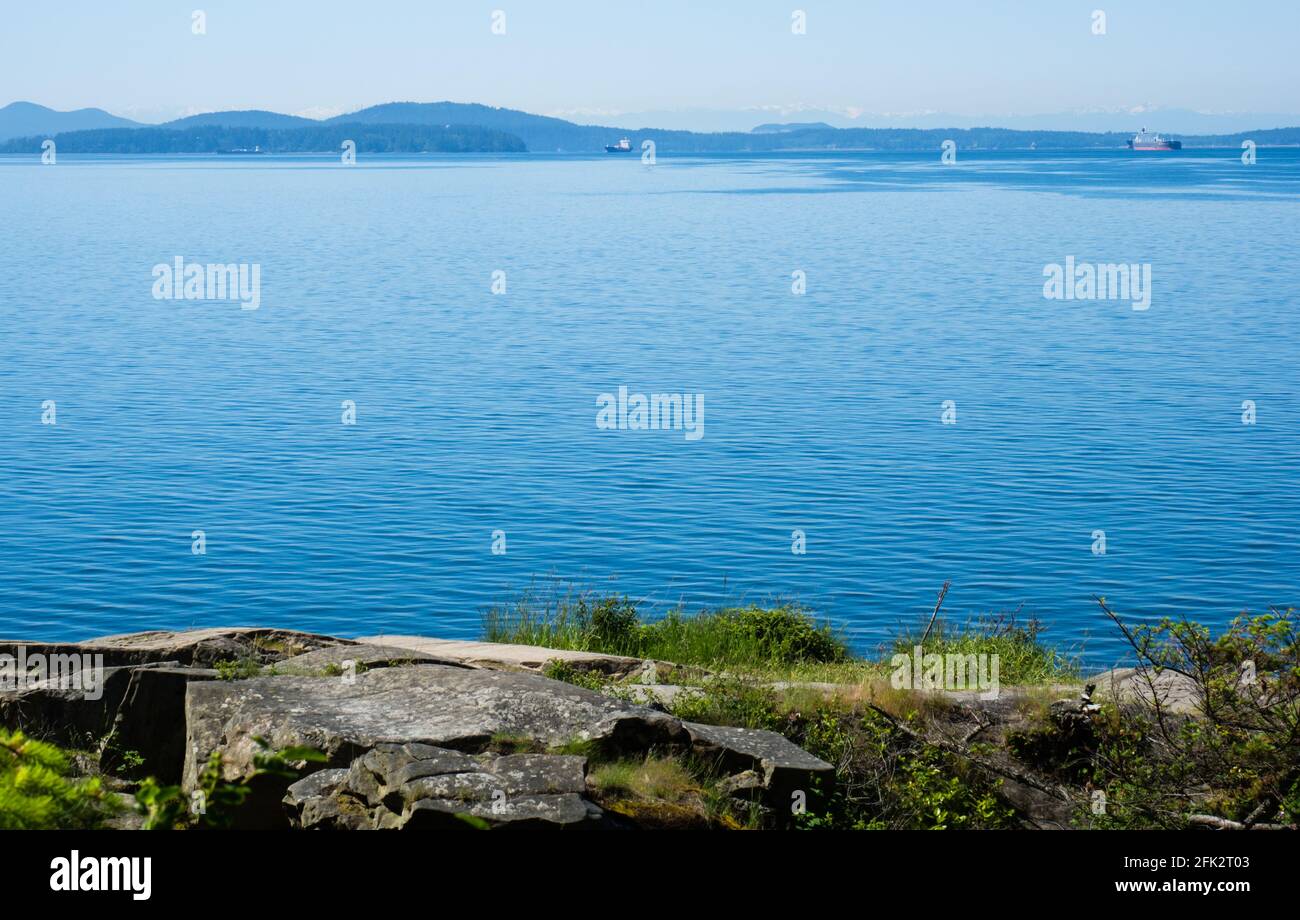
[0, 628, 833, 829]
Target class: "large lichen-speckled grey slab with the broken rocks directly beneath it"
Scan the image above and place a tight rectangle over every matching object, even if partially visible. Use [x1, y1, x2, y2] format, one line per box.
[185, 663, 832, 829]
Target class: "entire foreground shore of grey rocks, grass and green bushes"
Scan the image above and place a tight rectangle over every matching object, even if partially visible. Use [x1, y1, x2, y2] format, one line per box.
[0, 618, 1300, 830]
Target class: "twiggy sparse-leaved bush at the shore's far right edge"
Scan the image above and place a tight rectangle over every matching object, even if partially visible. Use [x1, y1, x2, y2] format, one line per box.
[1089, 602, 1300, 828]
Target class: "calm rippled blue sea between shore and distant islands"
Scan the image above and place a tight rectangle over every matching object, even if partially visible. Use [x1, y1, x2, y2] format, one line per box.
[0, 151, 1300, 663]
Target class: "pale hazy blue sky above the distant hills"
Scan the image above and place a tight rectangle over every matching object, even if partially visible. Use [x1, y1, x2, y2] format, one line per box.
[0, 0, 1300, 121]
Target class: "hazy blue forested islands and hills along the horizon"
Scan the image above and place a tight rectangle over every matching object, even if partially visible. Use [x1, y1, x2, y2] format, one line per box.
[0, 103, 1300, 153]
